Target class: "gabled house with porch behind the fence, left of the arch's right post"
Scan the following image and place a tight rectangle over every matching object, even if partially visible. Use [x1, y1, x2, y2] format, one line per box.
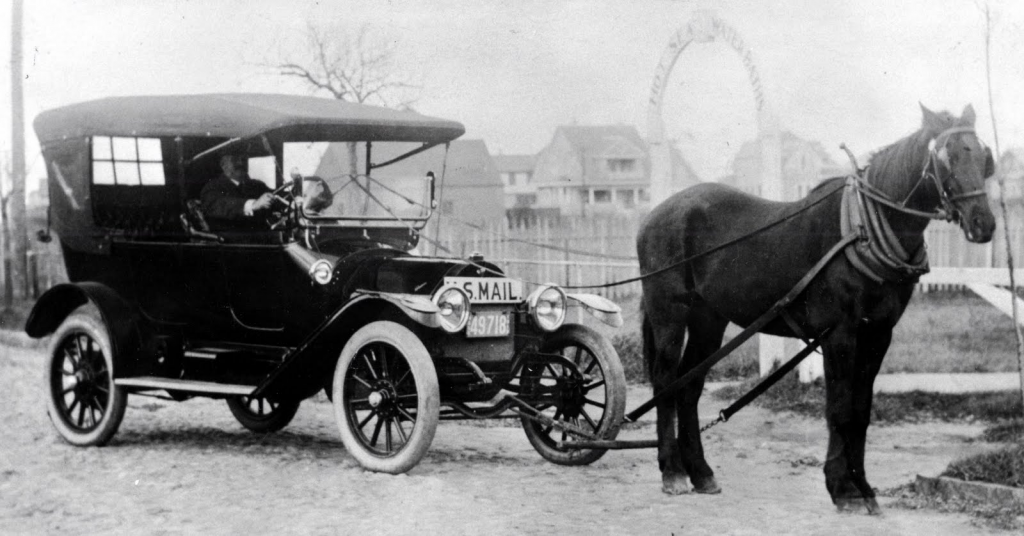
[532, 125, 699, 215]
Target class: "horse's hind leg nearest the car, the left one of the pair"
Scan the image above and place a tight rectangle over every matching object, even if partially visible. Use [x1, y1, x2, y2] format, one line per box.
[643, 305, 689, 495]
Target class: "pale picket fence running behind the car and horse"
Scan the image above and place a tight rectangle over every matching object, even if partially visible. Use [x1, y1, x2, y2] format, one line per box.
[12, 214, 1024, 300]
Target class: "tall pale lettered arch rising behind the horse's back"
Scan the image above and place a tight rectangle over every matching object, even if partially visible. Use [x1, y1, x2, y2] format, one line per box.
[647, 11, 782, 205]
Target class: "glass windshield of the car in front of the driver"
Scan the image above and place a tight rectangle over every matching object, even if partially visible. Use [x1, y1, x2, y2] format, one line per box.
[284, 141, 444, 220]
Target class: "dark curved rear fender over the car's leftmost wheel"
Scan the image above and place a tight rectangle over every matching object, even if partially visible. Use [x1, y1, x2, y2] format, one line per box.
[25, 282, 142, 375]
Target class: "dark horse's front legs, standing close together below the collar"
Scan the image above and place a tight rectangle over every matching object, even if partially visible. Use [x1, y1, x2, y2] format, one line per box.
[823, 325, 892, 513]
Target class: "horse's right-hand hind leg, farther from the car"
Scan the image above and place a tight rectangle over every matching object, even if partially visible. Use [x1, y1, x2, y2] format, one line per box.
[676, 305, 729, 494]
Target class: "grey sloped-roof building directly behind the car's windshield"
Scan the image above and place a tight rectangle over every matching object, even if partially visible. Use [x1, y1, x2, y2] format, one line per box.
[316, 139, 505, 224]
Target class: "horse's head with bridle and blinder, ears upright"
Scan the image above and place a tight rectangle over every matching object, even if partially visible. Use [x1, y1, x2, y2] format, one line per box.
[921, 105, 995, 243]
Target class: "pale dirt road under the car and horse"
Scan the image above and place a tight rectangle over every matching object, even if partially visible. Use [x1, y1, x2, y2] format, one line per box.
[0, 346, 1007, 536]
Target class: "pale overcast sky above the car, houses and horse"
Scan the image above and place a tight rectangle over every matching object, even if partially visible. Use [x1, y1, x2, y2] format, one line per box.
[0, 0, 1024, 186]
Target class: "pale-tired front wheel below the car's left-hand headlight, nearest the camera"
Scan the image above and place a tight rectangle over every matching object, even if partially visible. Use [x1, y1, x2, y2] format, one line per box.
[332, 321, 440, 475]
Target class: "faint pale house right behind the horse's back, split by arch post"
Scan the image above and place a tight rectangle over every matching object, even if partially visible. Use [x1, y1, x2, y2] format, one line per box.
[719, 131, 850, 201]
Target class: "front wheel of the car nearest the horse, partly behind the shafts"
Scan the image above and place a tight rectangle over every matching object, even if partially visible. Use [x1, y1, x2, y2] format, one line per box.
[521, 324, 626, 465]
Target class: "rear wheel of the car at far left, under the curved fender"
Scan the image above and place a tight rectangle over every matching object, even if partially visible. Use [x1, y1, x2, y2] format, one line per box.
[46, 310, 128, 447]
